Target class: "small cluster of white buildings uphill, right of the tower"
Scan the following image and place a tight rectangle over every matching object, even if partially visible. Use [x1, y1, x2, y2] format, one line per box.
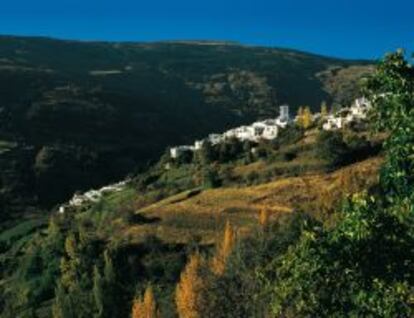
[322, 97, 371, 130]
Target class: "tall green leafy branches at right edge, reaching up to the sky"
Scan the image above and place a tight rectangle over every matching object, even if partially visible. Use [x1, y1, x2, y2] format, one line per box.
[366, 51, 414, 203]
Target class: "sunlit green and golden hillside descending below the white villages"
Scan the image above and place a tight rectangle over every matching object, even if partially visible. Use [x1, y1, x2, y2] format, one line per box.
[0, 127, 383, 317]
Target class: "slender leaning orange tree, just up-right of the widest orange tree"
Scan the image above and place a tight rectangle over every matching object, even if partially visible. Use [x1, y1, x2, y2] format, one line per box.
[211, 221, 236, 275]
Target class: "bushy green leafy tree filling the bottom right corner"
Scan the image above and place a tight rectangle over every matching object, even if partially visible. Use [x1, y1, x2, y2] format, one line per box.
[272, 195, 414, 317]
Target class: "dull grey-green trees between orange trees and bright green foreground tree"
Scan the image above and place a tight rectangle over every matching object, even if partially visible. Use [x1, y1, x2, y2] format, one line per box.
[197, 213, 308, 318]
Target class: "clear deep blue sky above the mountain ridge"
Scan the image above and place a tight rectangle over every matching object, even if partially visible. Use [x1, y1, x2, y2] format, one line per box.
[0, 0, 414, 58]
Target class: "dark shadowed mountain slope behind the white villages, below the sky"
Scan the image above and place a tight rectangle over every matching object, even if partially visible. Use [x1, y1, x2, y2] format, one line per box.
[0, 36, 371, 214]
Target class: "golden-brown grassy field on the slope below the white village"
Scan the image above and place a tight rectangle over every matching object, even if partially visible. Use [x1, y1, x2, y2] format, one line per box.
[124, 158, 382, 244]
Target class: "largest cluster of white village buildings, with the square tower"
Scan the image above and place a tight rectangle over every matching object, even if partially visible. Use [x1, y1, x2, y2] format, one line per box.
[170, 105, 291, 158]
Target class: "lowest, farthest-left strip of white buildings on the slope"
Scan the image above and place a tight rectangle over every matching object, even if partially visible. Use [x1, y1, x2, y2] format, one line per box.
[58, 180, 129, 213]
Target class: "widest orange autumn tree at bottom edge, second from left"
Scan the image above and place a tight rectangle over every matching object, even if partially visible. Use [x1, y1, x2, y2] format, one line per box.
[175, 254, 206, 318]
